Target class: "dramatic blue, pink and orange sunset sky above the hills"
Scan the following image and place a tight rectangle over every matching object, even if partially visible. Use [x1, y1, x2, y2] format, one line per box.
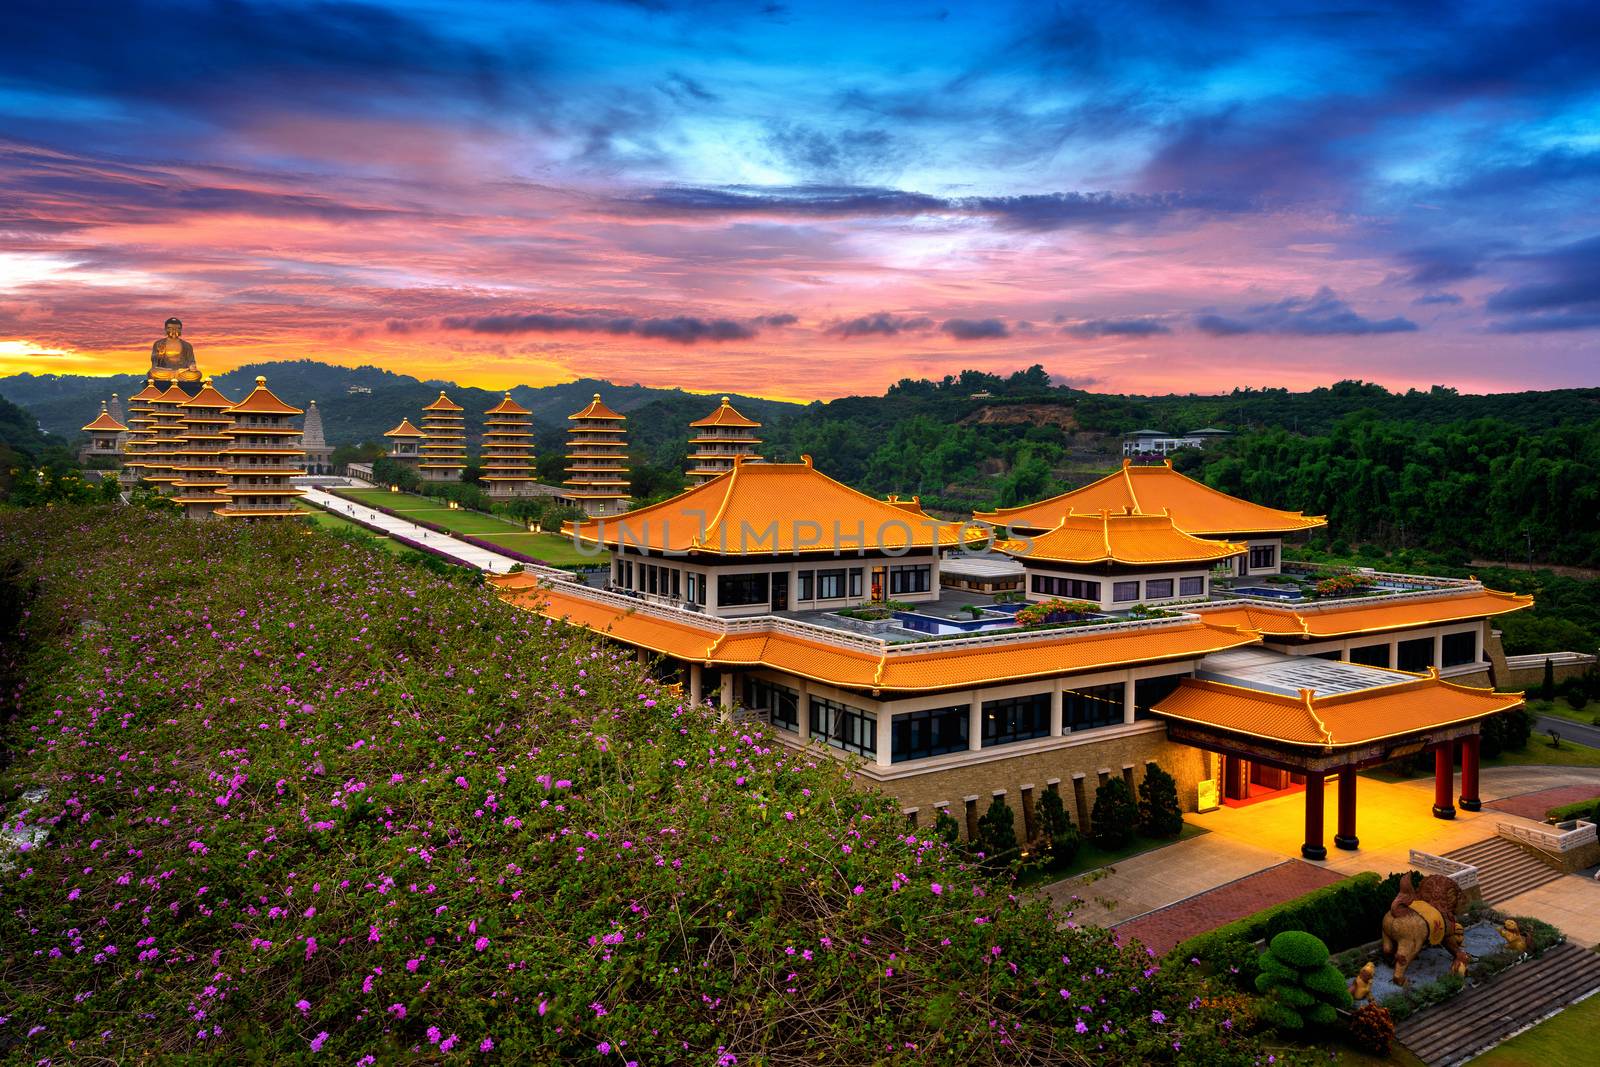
[0, 0, 1600, 398]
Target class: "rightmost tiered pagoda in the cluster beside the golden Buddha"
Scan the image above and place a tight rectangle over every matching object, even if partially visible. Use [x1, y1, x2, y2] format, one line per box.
[216, 376, 306, 518]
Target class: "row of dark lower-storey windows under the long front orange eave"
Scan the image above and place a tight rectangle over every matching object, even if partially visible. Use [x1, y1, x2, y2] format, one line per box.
[744, 675, 1184, 763]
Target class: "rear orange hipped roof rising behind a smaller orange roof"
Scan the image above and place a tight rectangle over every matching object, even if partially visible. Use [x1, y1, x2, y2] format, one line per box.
[973, 461, 1328, 537]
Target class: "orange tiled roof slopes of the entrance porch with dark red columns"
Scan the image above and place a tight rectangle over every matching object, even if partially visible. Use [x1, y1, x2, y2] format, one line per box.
[1154, 675, 1522, 749]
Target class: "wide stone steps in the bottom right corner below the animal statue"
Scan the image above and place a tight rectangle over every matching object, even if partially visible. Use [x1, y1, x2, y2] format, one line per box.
[1395, 941, 1600, 1067]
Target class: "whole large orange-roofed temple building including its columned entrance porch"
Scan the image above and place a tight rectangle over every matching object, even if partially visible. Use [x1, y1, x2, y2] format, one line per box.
[491, 462, 1531, 859]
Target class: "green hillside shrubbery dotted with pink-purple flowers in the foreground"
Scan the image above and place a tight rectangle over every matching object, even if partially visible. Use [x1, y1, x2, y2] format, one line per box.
[0, 507, 1264, 1067]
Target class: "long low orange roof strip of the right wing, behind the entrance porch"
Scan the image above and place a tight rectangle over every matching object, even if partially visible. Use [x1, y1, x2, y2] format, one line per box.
[1200, 589, 1533, 638]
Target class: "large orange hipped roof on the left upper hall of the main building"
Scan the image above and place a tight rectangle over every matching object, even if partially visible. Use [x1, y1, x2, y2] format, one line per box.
[562, 456, 982, 555]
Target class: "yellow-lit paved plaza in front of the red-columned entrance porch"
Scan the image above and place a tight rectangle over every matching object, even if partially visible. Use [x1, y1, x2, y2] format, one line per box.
[1040, 766, 1600, 945]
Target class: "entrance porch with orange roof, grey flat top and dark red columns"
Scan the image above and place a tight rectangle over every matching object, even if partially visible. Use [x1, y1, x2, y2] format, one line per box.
[1154, 653, 1522, 859]
